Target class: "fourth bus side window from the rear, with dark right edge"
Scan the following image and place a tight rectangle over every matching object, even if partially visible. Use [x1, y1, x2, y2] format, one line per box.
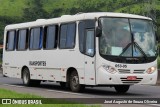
[44, 26, 58, 49]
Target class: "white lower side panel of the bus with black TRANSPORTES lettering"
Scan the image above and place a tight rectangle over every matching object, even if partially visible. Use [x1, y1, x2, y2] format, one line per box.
[3, 22, 85, 84]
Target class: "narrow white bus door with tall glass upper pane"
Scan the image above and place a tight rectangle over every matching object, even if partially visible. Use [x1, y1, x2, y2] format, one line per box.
[84, 29, 96, 85]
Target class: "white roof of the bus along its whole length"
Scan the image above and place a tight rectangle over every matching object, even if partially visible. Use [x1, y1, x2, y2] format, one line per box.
[5, 12, 152, 30]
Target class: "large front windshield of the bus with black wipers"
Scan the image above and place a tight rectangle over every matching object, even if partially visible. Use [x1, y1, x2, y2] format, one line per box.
[99, 17, 156, 57]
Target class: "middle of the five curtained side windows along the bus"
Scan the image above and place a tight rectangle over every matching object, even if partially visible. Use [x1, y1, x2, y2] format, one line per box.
[29, 28, 43, 49]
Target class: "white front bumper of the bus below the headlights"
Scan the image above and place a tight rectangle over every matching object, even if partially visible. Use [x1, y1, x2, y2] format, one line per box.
[96, 67, 158, 85]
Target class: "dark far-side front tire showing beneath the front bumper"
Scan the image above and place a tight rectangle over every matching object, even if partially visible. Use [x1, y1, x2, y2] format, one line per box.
[114, 85, 130, 94]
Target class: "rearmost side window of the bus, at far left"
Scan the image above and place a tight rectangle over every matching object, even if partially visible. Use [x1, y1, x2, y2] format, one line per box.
[6, 30, 16, 51]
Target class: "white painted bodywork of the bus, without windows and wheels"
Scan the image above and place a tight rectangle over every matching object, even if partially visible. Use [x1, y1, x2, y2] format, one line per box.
[3, 12, 157, 90]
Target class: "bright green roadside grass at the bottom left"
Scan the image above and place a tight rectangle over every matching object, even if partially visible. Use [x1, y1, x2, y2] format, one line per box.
[0, 89, 100, 107]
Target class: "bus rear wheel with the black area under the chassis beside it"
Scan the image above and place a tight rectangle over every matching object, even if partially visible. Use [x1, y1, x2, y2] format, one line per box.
[22, 68, 41, 86]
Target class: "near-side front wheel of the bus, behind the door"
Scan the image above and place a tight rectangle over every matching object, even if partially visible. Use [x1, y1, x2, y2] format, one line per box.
[70, 71, 85, 92]
